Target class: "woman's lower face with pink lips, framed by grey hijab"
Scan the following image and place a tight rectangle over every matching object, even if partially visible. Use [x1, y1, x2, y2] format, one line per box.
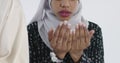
[51, 0, 78, 21]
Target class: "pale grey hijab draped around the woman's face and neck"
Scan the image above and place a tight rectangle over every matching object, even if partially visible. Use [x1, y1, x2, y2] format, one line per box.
[31, 0, 88, 50]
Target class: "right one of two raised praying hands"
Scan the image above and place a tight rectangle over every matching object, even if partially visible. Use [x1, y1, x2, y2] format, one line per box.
[70, 24, 94, 62]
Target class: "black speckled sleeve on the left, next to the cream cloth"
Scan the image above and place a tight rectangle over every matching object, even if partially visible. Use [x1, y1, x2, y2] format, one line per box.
[27, 22, 53, 63]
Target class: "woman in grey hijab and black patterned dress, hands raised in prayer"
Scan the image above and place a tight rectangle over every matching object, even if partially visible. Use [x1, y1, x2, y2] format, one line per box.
[28, 0, 104, 63]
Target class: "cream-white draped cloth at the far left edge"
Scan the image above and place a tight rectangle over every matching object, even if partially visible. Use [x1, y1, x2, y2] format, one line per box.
[0, 0, 29, 63]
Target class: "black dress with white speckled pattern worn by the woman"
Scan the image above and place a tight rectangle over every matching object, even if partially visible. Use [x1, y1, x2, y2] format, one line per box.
[27, 22, 104, 63]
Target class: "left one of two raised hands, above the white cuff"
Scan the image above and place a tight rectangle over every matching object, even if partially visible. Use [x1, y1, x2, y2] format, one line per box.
[48, 23, 71, 59]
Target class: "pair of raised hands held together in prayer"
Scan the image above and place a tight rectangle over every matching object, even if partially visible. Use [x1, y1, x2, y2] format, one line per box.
[48, 21, 94, 63]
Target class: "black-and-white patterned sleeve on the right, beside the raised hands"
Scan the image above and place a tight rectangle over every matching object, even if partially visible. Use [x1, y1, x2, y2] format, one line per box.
[80, 25, 104, 63]
